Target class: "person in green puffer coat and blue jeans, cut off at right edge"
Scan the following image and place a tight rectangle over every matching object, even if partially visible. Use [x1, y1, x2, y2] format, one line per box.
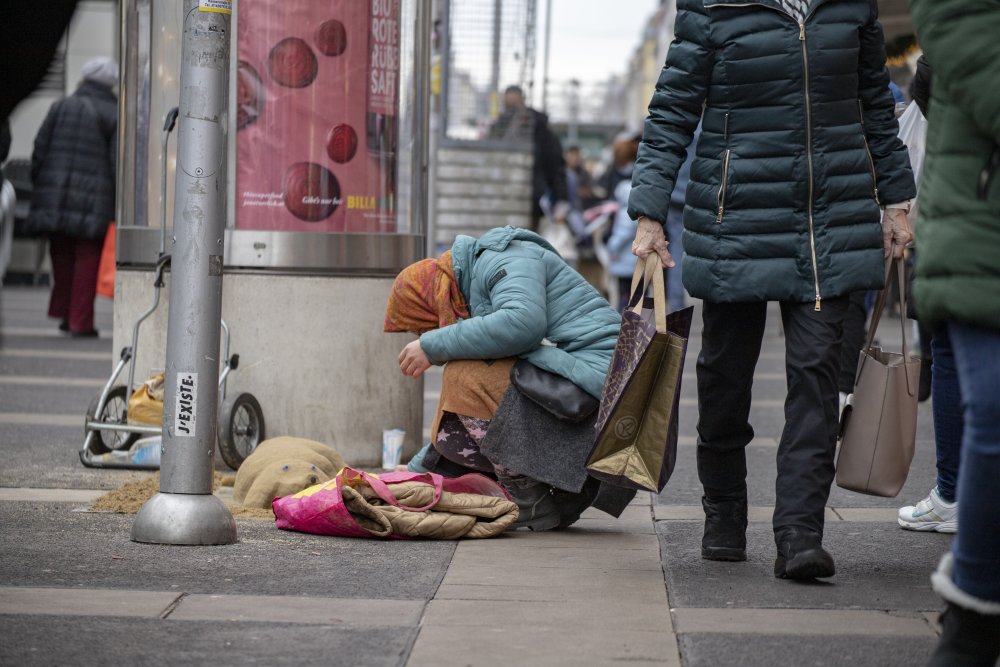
[910, 0, 1000, 666]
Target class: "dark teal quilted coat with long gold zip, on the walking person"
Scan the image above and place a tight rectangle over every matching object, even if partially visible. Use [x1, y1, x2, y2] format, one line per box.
[629, 0, 915, 308]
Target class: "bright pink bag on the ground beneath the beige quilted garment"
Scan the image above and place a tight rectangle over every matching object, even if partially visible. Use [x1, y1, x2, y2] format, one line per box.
[271, 467, 510, 538]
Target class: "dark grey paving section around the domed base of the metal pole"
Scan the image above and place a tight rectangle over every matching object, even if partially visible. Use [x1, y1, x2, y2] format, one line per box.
[0, 503, 455, 600]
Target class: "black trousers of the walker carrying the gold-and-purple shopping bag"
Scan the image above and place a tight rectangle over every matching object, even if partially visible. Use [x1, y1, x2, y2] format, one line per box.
[697, 296, 848, 536]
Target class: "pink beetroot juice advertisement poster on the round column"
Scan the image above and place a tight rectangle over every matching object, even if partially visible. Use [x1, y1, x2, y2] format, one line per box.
[236, 0, 400, 233]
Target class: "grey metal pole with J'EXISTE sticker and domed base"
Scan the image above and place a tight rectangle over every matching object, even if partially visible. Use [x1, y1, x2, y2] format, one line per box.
[132, 0, 236, 544]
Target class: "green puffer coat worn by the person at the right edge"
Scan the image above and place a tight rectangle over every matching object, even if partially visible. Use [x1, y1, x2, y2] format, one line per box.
[910, 0, 1000, 330]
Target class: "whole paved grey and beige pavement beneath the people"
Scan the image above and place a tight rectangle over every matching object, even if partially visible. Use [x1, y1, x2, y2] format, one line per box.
[0, 288, 949, 667]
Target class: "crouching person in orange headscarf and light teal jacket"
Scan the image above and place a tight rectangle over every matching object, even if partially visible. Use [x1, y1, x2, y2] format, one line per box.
[384, 227, 621, 530]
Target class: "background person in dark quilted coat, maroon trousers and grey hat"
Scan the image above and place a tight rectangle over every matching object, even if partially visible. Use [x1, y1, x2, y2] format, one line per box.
[27, 58, 118, 337]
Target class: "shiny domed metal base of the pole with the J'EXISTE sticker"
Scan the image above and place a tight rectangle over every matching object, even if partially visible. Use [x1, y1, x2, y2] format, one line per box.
[132, 492, 236, 545]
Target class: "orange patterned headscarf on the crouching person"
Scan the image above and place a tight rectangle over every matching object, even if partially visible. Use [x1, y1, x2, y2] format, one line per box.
[384, 250, 469, 334]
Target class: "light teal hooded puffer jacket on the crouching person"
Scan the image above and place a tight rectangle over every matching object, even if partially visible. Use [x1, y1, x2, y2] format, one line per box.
[420, 227, 621, 398]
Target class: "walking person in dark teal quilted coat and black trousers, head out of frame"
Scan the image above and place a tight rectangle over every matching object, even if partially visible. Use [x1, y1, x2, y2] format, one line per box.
[629, 0, 915, 579]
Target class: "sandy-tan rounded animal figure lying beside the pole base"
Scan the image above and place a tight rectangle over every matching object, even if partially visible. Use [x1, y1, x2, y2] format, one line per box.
[233, 436, 345, 509]
